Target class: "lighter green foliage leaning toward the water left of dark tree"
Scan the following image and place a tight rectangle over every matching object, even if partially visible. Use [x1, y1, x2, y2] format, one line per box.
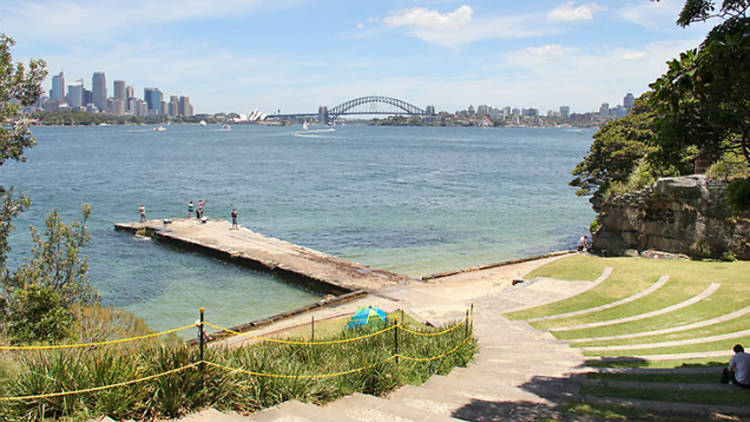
[570, 97, 654, 201]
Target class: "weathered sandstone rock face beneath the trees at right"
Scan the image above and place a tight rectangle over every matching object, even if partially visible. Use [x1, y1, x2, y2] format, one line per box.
[593, 175, 750, 259]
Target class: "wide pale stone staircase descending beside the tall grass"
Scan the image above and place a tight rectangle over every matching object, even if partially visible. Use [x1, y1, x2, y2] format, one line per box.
[162, 288, 584, 422]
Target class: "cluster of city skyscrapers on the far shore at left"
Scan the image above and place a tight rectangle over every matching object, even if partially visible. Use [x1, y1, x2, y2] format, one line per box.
[38, 72, 194, 118]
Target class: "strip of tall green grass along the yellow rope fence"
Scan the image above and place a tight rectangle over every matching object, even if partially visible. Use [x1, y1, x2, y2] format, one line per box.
[0, 320, 477, 421]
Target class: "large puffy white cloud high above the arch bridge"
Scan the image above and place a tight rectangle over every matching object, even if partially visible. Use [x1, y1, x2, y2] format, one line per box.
[383, 5, 558, 48]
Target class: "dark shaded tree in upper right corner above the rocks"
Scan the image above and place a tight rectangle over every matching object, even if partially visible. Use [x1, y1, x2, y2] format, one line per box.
[650, 0, 750, 169]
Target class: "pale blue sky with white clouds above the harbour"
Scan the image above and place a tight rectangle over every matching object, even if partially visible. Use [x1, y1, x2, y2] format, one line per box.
[0, 0, 715, 114]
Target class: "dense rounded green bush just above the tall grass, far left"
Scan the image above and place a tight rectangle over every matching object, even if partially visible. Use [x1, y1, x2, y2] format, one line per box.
[8, 284, 73, 343]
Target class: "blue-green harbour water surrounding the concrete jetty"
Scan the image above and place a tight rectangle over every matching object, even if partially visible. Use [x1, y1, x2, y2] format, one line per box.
[0, 125, 594, 329]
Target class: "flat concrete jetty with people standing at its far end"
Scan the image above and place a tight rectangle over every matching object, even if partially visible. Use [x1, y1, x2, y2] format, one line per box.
[115, 218, 412, 296]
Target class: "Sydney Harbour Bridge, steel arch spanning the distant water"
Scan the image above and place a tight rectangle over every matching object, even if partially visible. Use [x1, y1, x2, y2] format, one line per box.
[268, 96, 435, 124]
